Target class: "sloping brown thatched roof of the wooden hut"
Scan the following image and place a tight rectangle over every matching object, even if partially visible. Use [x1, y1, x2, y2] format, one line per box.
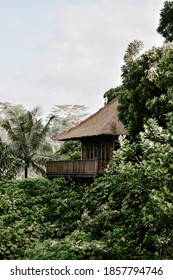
[58, 98, 127, 140]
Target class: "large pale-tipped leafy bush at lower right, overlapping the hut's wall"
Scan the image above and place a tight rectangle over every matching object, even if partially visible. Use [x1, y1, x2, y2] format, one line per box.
[80, 114, 173, 259]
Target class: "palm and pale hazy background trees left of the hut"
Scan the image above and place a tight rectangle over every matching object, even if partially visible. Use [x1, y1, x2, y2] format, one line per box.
[0, 102, 88, 176]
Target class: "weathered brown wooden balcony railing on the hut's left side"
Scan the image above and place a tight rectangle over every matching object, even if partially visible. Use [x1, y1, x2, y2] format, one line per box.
[46, 159, 108, 179]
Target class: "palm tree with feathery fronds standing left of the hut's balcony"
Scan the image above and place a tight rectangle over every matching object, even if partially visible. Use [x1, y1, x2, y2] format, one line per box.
[2, 107, 54, 178]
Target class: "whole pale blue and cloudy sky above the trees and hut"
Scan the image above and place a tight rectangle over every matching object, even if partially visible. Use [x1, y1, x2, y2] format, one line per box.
[0, 0, 164, 116]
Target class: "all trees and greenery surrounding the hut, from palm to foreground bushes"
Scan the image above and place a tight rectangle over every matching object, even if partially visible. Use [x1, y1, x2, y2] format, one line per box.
[0, 1, 173, 260]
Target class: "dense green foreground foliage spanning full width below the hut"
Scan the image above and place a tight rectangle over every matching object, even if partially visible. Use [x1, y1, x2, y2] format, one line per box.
[0, 116, 173, 260]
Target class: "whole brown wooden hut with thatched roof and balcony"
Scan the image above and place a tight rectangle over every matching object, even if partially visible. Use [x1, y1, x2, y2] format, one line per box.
[46, 98, 127, 178]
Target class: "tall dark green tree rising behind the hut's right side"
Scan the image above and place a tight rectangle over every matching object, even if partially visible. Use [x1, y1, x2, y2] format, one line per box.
[104, 1, 173, 139]
